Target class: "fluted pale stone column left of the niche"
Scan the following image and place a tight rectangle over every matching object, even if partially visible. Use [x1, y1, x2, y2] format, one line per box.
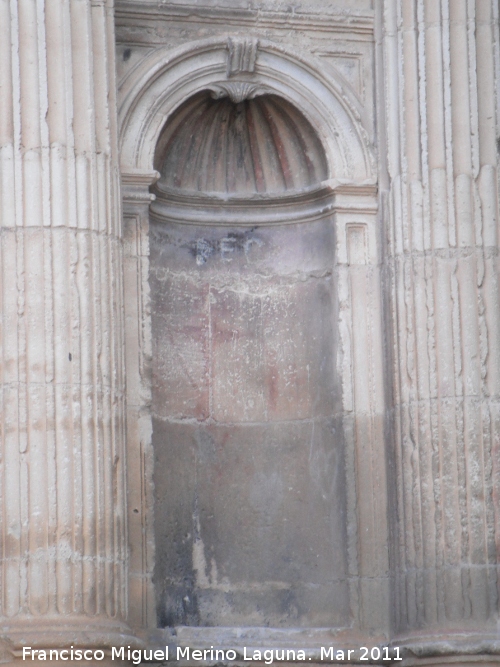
[0, 0, 133, 649]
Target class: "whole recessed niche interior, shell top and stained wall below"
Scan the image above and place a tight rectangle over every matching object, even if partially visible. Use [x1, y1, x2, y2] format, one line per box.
[150, 91, 349, 628]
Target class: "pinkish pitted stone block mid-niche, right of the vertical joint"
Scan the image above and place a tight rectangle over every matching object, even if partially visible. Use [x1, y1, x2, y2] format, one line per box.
[210, 277, 335, 422]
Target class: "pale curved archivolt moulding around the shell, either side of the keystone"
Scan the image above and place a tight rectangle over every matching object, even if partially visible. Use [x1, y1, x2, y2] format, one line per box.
[119, 37, 376, 183]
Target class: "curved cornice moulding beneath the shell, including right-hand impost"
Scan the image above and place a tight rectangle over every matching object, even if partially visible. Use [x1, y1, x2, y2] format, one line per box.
[151, 181, 377, 227]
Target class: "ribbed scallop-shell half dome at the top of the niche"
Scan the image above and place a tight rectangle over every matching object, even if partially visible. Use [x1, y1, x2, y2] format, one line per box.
[156, 92, 328, 194]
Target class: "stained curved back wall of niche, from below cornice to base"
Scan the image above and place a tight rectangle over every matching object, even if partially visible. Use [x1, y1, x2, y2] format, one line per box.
[151, 209, 348, 626]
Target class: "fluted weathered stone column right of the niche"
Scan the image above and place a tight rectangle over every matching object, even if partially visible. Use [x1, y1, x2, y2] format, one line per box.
[381, 0, 500, 654]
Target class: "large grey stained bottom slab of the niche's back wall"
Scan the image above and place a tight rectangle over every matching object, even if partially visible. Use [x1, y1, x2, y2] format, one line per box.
[153, 419, 349, 627]
